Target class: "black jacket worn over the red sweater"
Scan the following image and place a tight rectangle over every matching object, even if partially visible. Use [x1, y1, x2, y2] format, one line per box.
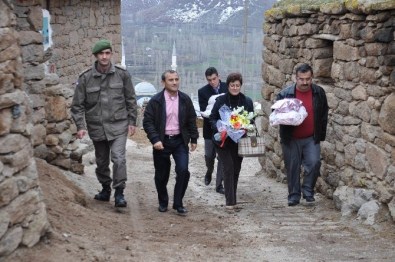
[276, 84, 329, 144]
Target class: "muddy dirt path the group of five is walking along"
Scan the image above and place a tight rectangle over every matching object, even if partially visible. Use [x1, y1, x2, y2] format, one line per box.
[5, 130, 395, 262]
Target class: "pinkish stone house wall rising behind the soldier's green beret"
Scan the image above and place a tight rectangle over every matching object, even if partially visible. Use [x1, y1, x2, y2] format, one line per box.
[46, 0, 122, 85]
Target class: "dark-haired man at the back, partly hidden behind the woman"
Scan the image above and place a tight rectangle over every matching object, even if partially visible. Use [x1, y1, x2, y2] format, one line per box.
[198, 67, 228, 194]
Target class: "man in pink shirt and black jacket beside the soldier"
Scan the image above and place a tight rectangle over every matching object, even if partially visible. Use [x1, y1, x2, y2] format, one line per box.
[143, 70, 199, 215]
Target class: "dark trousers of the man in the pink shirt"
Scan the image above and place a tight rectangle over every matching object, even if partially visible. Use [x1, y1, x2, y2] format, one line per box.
[153, 136, 190, 207]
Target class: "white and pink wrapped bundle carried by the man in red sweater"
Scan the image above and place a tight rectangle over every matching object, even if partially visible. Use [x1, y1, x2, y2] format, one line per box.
[269, 98, 307, 126]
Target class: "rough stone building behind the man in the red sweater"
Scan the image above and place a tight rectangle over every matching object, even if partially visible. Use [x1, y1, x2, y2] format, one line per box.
[261, 0, 395, 223]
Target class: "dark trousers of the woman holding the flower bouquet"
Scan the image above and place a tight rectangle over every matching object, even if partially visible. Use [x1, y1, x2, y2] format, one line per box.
[218, 143, 243, 206]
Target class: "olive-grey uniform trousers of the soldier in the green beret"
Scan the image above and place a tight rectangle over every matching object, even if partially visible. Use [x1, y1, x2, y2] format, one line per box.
[93, 135, 127, 188]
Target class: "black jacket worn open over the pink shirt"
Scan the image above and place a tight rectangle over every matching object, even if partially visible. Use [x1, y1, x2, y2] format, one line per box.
[143, 89, 199, 146]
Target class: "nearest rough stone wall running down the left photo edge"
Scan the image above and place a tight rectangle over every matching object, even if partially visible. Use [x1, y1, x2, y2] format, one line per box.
[0, 0, 49, 260]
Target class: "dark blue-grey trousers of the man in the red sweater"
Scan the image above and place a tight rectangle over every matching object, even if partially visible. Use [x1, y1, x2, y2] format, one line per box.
[281, 137, 321, 200]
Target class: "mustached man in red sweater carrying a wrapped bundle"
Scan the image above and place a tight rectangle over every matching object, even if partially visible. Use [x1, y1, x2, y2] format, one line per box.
[277, 64, 328, 206]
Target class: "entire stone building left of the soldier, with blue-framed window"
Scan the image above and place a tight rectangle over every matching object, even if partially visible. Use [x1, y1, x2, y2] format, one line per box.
[0, 0, 121, 260]
